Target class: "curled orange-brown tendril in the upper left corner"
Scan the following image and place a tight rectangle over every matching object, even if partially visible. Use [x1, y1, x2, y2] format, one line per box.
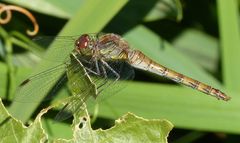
[0, 3, 39, 36]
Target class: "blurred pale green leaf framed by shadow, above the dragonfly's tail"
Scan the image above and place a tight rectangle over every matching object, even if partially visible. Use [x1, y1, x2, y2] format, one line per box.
[173, 29, 219, 72]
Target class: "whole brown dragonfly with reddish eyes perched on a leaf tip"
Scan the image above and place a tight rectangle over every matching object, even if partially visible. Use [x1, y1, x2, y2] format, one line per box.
[15, 33, 230, 119]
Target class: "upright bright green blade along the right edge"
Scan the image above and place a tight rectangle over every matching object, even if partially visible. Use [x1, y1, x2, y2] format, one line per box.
[217, 0, 240, 93]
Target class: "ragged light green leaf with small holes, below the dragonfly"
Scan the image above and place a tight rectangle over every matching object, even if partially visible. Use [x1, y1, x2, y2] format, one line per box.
[55, 113, 173, 143]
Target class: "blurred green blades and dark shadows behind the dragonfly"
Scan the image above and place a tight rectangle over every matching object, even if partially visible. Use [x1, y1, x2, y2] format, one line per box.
[0, 0, 240, 143]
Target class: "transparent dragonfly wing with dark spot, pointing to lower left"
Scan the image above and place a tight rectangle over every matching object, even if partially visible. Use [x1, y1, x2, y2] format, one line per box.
[13, 64, 66, 103]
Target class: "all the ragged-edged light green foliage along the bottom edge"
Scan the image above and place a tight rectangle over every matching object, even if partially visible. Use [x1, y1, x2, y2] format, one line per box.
[0, 100, 173, 143]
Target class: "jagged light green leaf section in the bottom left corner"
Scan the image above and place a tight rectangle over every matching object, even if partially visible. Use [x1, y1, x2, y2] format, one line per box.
[0, 99, 47, 143]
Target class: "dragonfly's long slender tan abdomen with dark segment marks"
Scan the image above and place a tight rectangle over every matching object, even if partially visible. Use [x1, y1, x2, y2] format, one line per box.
[128, 50, 230, 101]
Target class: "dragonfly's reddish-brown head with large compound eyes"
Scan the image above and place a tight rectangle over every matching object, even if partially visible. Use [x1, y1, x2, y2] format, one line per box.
[75, 34, 94, 54]
